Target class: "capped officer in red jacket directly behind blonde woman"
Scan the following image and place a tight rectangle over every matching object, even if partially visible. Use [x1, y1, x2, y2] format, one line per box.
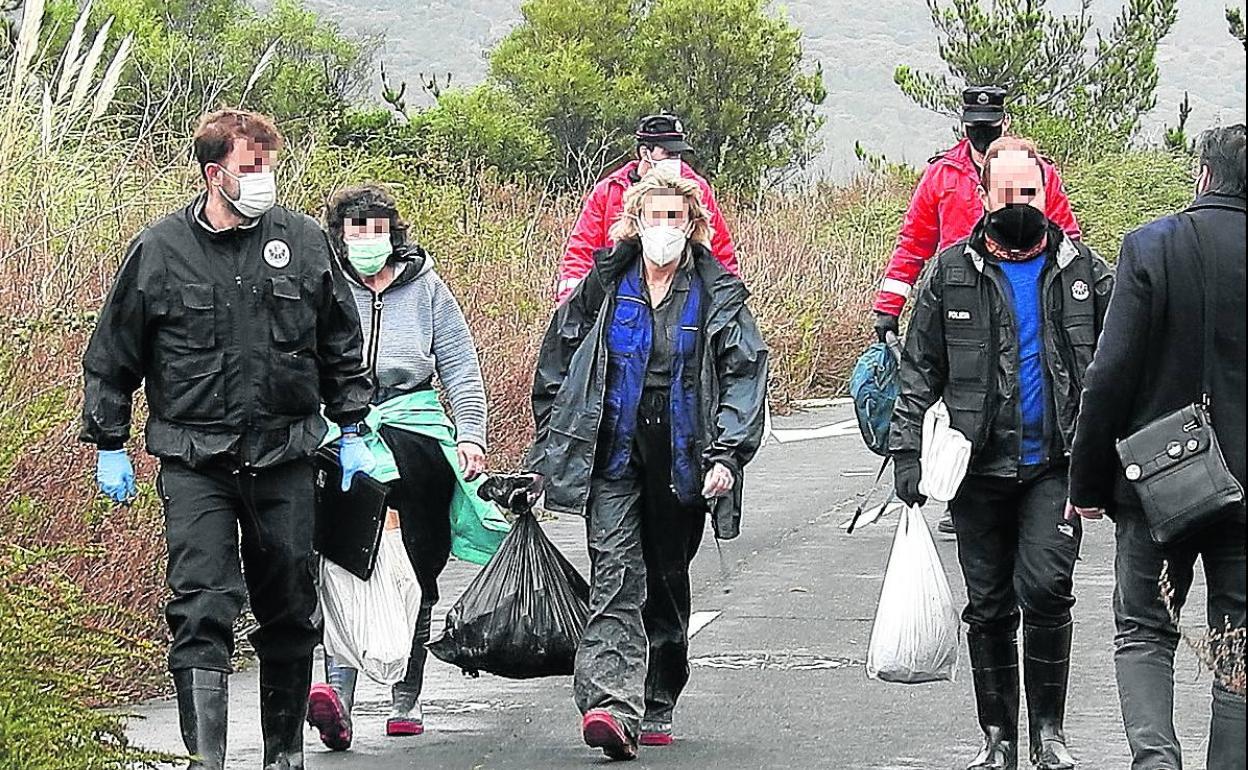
[555, 114, 740, 303]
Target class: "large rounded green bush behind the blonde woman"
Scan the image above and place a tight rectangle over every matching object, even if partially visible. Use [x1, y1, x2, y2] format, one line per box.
[490, 0, 827, 191]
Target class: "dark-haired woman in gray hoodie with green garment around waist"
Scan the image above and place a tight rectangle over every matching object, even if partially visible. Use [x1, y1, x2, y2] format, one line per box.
[308, 185, 507, 751]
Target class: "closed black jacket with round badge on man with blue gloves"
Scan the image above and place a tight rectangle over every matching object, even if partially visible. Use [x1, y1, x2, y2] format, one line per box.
[81, 196, 372, 467]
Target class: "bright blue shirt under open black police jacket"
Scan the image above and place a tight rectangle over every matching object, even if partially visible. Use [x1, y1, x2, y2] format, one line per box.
[1001, 252, 1050, 465]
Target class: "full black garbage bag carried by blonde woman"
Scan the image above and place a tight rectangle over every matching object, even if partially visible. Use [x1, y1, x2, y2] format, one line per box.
[428, 474, 589, 679]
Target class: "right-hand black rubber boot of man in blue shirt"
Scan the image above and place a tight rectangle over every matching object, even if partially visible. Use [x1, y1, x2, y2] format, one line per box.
[1022, 623, 1076, 770]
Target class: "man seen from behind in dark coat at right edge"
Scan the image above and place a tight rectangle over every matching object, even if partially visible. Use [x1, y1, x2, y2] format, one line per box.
[1068, 124, 1248, 770]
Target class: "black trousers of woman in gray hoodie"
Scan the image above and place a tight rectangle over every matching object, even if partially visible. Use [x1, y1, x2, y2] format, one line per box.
[381, 427, 458, 696]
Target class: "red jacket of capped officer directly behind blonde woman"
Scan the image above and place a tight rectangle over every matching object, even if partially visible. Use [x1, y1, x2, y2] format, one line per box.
[555, 161, 740, 305]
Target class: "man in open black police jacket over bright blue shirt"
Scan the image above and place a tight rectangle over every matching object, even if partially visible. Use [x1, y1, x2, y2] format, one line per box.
[890, 137, 1113, 770]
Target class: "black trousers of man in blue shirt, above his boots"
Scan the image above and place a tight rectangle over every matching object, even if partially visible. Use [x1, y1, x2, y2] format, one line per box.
[948, 467, 1083, 634]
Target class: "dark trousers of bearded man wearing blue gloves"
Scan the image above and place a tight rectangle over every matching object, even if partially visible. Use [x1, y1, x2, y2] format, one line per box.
[157, 461, 321, 671]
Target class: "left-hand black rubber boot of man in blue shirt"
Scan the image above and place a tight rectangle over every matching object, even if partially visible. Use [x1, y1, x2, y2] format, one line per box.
[966, 631, 1018, 770]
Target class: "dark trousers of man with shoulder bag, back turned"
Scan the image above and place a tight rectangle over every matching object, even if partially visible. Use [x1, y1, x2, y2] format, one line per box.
[1113, 507, 1246, 770]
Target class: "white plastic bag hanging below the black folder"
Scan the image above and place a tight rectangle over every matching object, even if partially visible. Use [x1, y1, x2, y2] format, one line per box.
[319, 529, 421, 684]
